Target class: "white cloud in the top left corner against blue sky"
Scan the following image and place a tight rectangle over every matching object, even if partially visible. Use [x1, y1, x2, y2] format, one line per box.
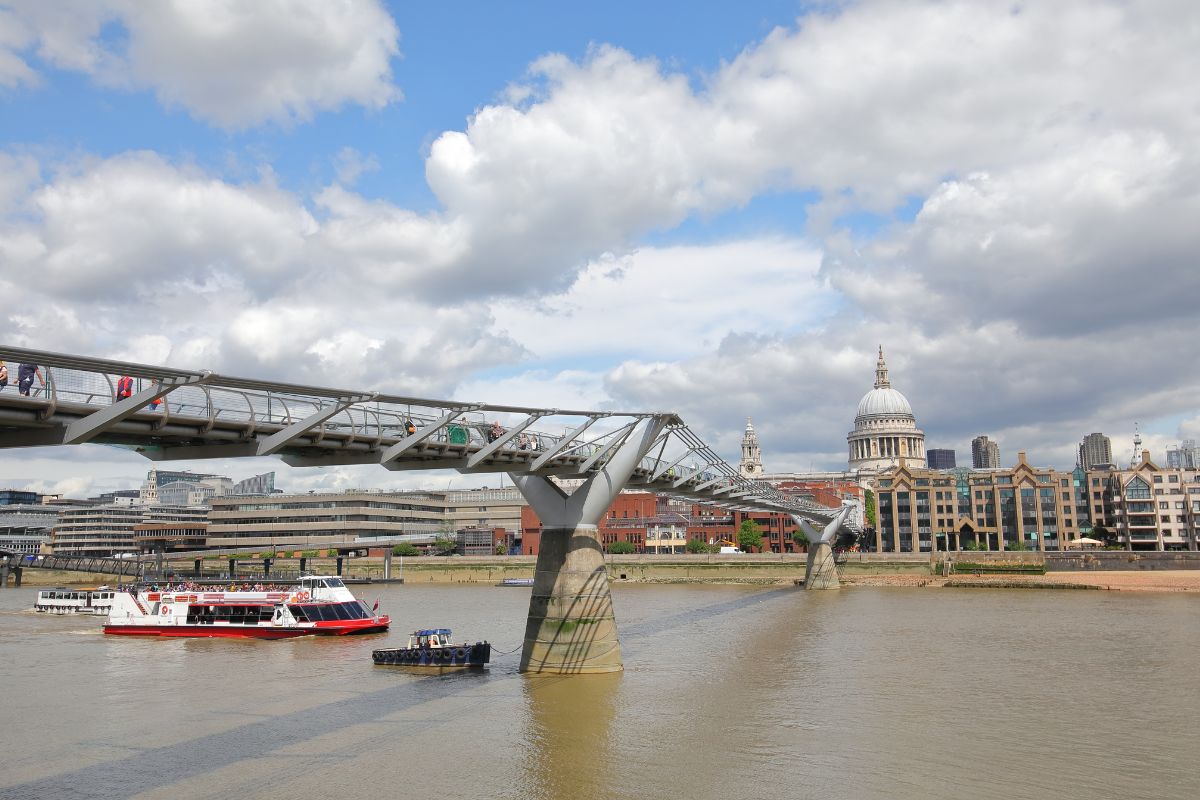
[0, 0, 400, 128]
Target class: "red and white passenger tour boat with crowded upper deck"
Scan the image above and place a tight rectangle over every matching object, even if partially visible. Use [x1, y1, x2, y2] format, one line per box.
[104, 576, 390, 639]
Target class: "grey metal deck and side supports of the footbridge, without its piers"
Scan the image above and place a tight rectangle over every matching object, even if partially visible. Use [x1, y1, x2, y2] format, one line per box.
[0, 347, 838, 523]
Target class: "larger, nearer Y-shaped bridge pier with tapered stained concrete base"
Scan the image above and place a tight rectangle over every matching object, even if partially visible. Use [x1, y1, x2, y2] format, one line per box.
[512, 417, 665, 674]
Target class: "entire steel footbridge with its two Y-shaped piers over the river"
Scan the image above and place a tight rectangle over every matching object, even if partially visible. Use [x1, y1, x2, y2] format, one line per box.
[0, 345, 850, 673]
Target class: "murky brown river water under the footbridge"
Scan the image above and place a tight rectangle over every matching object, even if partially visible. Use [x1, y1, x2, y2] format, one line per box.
[0, 584, 1200, 800]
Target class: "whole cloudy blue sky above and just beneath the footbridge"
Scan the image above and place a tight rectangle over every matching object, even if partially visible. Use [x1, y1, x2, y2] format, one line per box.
[0, 0, 1200, 495]
